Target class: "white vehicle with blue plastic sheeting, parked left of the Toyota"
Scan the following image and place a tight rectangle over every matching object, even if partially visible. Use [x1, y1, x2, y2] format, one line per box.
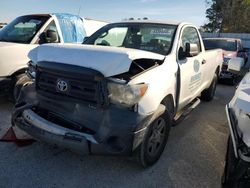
[0, 13, 105, 97]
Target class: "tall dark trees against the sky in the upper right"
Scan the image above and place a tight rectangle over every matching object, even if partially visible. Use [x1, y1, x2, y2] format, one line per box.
[202, 0, 250, 33]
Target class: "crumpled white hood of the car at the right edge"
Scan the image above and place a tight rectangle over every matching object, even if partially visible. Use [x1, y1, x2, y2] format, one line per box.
[229, 73, 250, 147]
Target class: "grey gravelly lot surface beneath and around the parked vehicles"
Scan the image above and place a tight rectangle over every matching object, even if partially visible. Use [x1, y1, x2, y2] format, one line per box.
[0, 85, 235, 188]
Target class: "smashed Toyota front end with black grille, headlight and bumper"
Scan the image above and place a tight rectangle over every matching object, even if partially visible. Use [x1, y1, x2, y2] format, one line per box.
[12, 61, 162, 155]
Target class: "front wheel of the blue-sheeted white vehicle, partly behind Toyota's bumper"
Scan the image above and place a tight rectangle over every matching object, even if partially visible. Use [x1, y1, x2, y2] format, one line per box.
[13, 74, 31, 102]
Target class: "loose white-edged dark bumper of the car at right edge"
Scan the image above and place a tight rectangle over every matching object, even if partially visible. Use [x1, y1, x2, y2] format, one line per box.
[226, 105, 250, 162]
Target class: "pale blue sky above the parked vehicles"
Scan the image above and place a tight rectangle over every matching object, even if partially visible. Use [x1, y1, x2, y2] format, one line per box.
[0, 0, 206, 26]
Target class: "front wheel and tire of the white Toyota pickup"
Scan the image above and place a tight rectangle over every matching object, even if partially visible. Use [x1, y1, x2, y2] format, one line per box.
[136, 111, 171, 167]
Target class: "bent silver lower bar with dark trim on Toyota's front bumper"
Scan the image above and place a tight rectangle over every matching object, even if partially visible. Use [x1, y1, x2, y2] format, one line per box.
[15, 109, 94, 154]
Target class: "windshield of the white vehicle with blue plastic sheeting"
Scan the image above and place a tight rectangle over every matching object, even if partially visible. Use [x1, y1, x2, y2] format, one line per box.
[0, 16, 49, 44]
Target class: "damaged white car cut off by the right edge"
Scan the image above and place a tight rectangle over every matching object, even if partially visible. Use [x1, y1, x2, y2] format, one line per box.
[222, 70, 250, 188]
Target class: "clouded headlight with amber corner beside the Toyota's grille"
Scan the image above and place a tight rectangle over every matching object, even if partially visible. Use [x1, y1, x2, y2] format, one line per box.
[108, 82, 148, 107]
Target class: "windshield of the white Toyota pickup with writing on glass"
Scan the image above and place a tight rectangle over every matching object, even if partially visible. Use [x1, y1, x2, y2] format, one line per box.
[84, 23, 177, 55]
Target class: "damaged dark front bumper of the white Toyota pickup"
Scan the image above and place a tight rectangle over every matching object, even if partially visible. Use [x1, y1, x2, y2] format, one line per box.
[12, 85, 165, 155]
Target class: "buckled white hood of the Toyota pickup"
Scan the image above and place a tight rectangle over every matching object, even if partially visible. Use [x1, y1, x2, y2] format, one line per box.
[29, 44, 165, 77]
